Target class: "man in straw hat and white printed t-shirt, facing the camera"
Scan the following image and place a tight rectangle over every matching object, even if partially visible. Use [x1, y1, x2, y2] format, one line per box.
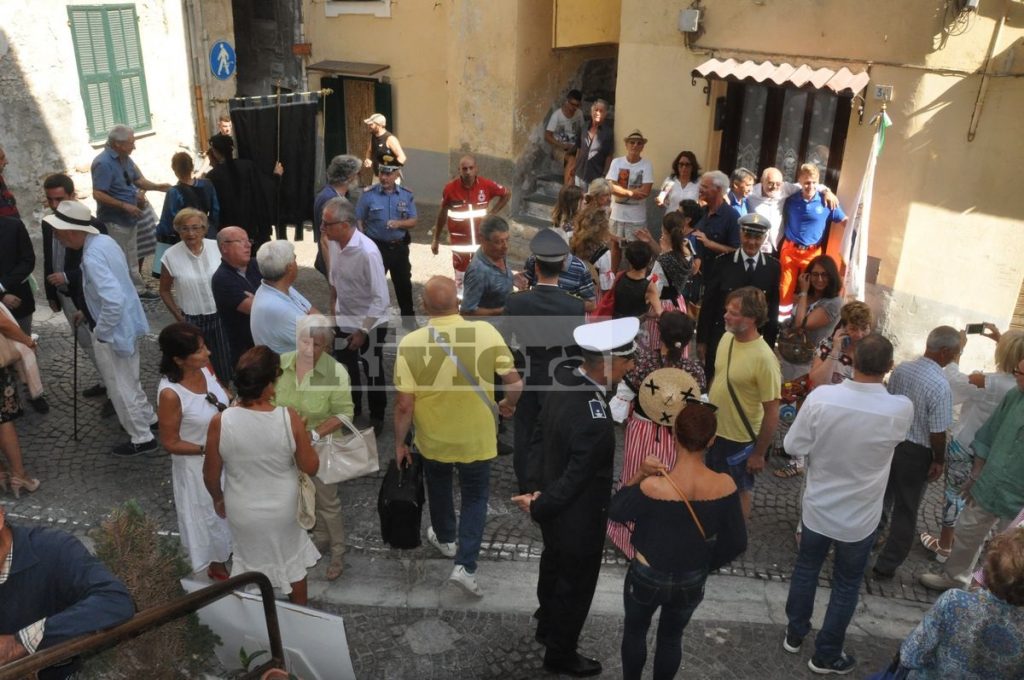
[605, 130, 654, 271]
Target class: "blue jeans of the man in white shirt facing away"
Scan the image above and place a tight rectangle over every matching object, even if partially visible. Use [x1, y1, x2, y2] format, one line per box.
[785, 524, 874, 664]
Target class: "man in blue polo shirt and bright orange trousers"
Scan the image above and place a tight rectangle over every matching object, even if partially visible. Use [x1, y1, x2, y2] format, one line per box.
[778, 163, 846, 315]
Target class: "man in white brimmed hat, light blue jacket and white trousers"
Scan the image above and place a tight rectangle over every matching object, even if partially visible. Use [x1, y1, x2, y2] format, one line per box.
[43, 201, 157, 457]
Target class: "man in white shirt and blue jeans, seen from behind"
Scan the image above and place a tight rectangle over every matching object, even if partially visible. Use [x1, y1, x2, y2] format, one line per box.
[782, 334, 913, 674]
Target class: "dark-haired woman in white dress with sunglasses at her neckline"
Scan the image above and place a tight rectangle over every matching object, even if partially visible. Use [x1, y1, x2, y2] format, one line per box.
[157, 324, 231, 581]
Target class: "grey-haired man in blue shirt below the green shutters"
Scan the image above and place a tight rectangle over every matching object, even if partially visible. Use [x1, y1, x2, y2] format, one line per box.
[91, 125, 171, 300]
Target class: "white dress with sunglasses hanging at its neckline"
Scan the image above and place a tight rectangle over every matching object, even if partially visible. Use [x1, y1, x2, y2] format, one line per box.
[157, 369, 231, 571]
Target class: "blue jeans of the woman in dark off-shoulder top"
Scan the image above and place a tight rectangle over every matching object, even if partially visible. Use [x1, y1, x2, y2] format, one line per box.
[622, 560, 708, 680]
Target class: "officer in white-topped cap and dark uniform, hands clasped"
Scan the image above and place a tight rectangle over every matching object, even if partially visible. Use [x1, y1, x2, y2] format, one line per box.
[512, 317, 640, 677]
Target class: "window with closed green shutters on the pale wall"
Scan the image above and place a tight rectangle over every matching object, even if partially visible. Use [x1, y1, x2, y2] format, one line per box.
[68, 5, 152, 141]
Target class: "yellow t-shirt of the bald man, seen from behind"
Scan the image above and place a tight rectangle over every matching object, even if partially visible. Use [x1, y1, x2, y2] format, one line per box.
[394, 314, 514, 463]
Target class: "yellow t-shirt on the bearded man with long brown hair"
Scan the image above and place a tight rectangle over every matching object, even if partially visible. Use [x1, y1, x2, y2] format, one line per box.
[708, 333, 782, 441]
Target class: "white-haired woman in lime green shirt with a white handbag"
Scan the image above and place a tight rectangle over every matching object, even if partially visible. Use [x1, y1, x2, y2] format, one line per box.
[273, 314, 353, 581]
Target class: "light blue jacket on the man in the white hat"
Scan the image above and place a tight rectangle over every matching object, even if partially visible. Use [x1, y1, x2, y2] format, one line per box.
[82, 233, 150, 356]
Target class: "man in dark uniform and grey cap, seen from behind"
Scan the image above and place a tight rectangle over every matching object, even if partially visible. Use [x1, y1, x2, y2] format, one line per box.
[504, 229, 586, 494]
